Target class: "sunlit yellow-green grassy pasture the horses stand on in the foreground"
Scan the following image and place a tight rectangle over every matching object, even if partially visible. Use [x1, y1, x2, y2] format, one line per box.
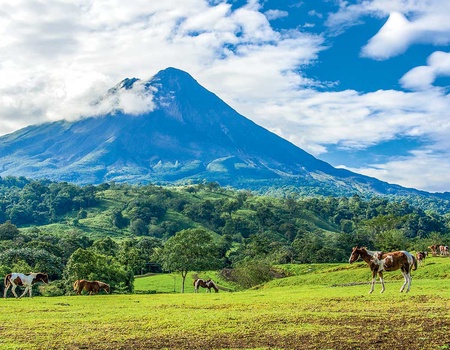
[0, 257, 450, 349]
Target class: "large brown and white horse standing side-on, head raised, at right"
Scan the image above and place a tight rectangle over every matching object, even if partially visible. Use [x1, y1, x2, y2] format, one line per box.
[348, 247, 417, 294]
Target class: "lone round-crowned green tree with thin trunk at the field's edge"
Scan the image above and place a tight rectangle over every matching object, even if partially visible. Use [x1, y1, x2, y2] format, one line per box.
[154, 228, 220, 293]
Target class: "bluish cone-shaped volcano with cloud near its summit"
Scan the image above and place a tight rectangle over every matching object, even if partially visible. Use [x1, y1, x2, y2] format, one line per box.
[0, 68, 444, 198]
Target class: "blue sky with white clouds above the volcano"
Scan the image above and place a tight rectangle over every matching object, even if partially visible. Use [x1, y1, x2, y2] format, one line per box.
[0, 0, 450, 192]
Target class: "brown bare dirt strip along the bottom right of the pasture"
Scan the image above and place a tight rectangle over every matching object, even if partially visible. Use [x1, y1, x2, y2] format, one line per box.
[58, 315, 450, 350]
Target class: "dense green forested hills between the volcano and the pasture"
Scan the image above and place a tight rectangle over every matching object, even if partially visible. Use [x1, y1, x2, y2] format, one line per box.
[0, 177, 450, 294]
